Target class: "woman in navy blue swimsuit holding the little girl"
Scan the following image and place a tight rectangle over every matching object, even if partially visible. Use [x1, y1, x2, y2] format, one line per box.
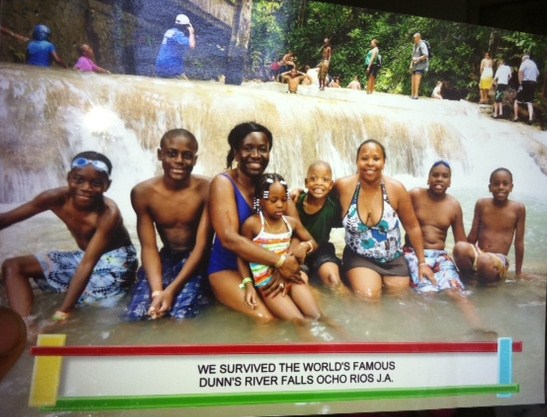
[208, 122, 300, 322]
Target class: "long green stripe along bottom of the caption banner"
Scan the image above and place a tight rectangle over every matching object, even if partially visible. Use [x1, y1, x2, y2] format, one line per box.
[41, 384, 519, 411]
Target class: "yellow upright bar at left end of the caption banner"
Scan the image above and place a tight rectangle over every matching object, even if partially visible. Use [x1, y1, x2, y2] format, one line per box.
[29, 334, 66, 407]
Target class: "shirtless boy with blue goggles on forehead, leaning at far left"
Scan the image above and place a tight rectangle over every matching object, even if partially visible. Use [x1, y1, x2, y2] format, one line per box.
[0, 152, 137, 320]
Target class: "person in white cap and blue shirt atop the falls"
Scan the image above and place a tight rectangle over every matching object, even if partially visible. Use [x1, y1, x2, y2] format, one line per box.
[156, 14, 196, 78]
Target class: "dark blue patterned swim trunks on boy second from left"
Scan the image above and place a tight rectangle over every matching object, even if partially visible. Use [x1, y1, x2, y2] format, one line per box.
[125, 247, 211, 320]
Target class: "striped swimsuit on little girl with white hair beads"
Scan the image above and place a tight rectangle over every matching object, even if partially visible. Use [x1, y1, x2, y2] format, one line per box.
[249, 212, 292, 288]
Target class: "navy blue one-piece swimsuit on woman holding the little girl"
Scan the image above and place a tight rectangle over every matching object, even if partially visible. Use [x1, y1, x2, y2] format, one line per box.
[207, 173, 253, 275]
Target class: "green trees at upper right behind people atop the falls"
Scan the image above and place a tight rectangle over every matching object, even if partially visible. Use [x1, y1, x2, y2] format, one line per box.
[250, 0, 547, 98]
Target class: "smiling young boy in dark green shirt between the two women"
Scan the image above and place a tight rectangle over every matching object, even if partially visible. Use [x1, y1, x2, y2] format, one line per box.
[296, 161, 345, 290]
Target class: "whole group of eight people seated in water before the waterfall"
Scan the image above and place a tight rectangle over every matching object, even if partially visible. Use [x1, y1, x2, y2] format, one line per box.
[0, 122, 525, 342]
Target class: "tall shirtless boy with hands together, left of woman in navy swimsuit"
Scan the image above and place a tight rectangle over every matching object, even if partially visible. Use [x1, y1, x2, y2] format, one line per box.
[127, 129, 211, 320]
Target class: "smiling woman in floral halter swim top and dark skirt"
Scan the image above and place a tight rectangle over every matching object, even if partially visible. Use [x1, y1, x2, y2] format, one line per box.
[334, 139, 433, 300]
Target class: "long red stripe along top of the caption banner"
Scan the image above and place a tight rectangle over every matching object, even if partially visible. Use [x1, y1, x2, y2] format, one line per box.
[31, 341, 522, 356]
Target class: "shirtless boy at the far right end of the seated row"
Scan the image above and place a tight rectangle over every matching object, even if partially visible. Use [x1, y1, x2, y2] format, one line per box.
[454, 168, 526, 284]
